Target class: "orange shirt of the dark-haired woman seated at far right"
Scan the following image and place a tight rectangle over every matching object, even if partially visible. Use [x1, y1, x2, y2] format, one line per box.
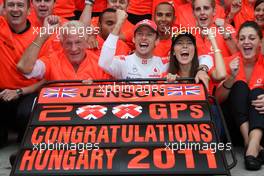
[225, 52, 264, 89]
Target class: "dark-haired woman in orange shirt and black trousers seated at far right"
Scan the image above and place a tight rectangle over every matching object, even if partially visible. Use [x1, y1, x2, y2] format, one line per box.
[216, 21, 264, 170]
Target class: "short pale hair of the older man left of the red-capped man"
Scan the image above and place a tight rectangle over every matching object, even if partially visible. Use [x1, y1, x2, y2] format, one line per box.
[59, 20, 87, 42]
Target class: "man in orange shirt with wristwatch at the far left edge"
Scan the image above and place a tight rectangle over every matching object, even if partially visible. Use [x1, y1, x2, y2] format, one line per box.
[0, 0, 44, 145]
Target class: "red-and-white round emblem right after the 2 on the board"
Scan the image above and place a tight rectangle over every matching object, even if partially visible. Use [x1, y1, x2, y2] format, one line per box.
[76, 105, 107, 120]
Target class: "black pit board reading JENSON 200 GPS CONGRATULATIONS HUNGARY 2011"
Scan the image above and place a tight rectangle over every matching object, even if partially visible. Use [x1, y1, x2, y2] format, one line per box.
[11, 83, 235, 176]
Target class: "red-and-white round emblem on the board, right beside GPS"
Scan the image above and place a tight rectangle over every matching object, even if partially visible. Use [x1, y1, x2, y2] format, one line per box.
[112, 104, 142, 119]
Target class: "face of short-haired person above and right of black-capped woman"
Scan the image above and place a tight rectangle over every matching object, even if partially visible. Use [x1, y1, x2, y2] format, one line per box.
[193, 0, 215, 28]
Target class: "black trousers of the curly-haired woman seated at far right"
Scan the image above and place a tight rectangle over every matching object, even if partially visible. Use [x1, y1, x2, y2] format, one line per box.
[222, 81, 264, 144]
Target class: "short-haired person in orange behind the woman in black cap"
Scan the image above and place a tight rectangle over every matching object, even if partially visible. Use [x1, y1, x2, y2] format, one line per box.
[191, 0, 237, 57]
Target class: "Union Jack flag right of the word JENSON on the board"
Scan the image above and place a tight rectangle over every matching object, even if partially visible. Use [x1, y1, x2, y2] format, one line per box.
[168, 86, 201, 96]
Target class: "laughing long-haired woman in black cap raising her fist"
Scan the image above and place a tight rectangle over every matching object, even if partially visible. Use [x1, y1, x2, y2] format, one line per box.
[167, 32, 226, 94]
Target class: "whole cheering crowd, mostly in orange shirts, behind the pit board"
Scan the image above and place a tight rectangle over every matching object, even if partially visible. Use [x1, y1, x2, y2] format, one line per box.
[0, 0, 264, 170]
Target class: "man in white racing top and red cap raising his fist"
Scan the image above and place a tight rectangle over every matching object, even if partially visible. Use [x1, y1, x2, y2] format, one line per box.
[99, 10, 168, 79]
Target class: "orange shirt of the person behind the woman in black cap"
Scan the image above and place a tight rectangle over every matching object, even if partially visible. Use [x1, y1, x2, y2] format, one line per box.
[194, 24, 236, 57]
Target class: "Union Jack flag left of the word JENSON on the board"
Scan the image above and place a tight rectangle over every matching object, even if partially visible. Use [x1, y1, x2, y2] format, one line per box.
[43, 88, 78, 98]
